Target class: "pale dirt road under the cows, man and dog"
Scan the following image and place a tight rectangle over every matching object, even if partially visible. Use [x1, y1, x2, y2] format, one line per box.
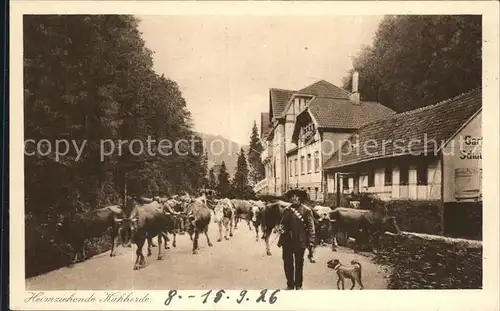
[26, 223, 389, 290]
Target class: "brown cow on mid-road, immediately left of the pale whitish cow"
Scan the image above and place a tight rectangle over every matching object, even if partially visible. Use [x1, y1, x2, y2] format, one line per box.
[184, 199, 213, 254]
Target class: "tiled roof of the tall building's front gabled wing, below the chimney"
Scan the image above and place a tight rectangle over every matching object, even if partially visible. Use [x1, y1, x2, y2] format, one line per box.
[308, 97, 395, 129]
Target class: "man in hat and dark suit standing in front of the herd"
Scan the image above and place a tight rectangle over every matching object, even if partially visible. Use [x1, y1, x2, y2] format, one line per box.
[278, 190, 315, 290]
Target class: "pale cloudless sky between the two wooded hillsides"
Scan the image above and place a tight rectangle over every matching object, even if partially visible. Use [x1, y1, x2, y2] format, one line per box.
[138, 15, 383, 145]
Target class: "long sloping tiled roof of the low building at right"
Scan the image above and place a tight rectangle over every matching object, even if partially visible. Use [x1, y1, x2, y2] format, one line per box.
[323, 89, 482, 169]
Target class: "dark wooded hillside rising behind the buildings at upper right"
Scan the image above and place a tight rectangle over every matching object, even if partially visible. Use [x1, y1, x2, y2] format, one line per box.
[343, 15, 482, 112]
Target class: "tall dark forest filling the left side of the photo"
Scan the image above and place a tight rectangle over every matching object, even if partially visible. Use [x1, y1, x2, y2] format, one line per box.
[23, 15, 207, 276]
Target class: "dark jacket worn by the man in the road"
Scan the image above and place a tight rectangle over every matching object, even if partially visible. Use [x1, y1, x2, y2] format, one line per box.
[278, 205, 315, 250]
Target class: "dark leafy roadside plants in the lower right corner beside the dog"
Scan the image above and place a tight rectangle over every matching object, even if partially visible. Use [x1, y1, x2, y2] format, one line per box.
[374, 234, 482, 289]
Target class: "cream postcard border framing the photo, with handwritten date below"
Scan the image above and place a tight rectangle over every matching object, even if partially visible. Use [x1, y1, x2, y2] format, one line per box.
[10, 0, 500, 310]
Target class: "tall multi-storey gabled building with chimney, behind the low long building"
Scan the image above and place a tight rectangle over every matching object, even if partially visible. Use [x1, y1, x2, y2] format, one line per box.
[256, 73, 395, 201]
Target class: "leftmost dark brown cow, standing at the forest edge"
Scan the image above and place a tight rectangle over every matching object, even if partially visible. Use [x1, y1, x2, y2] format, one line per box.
[56, 205, 123, 263]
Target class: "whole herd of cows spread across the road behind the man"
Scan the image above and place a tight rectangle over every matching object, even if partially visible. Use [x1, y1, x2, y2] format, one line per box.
[50, 194, 400, 270]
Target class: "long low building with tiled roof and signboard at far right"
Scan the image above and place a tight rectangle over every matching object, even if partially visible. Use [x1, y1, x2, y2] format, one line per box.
[323, 89, 482, 238]
